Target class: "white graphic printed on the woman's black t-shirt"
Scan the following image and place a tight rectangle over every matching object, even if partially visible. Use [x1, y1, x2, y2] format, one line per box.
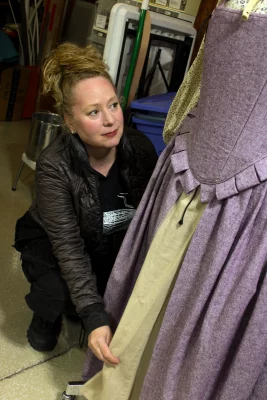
[103, 193, 135, 235]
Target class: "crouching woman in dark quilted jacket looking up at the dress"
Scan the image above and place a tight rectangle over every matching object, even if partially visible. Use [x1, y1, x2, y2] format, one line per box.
[15, 43, 157, 351]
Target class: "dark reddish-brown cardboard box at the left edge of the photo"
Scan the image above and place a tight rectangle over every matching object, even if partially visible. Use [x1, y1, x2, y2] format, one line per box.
[0, 66, 30, 121]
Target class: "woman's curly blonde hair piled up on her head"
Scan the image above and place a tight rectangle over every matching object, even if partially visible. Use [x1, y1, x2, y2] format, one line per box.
[42, 42, 113, 119]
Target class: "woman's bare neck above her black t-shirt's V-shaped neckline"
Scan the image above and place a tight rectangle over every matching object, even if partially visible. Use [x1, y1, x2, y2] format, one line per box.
[86, 146, 117, 176]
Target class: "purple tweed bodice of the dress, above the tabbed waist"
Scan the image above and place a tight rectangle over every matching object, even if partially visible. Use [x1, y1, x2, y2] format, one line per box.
[184, 7, 267, 195]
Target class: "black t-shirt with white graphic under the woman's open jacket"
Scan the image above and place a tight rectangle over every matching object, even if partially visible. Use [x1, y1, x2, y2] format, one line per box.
[90, 161, 135, 295]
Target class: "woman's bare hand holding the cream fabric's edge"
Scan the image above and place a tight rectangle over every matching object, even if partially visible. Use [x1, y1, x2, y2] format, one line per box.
[88, 326, 120, 365]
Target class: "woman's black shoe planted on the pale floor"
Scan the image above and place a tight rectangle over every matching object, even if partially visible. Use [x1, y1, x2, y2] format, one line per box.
[27, 314, 61, 351]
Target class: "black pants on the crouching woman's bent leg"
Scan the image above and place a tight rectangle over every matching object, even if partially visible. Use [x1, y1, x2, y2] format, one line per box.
[14, 212, 75, 322]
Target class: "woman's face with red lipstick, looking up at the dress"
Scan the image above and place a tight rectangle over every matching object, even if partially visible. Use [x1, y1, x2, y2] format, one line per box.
[68, 76, 123, 149]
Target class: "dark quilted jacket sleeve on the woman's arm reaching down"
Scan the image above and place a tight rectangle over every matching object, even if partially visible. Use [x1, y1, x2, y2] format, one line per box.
[35, 158, 104, 318]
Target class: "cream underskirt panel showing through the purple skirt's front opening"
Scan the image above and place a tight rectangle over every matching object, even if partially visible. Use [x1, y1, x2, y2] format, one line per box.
[82, 193, 206, 400]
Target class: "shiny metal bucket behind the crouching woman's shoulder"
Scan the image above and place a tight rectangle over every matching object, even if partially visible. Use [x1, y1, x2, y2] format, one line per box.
[26, 112, 62, 161]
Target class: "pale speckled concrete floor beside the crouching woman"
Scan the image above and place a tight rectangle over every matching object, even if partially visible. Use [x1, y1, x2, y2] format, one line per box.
[0, 120, 86, 400]
